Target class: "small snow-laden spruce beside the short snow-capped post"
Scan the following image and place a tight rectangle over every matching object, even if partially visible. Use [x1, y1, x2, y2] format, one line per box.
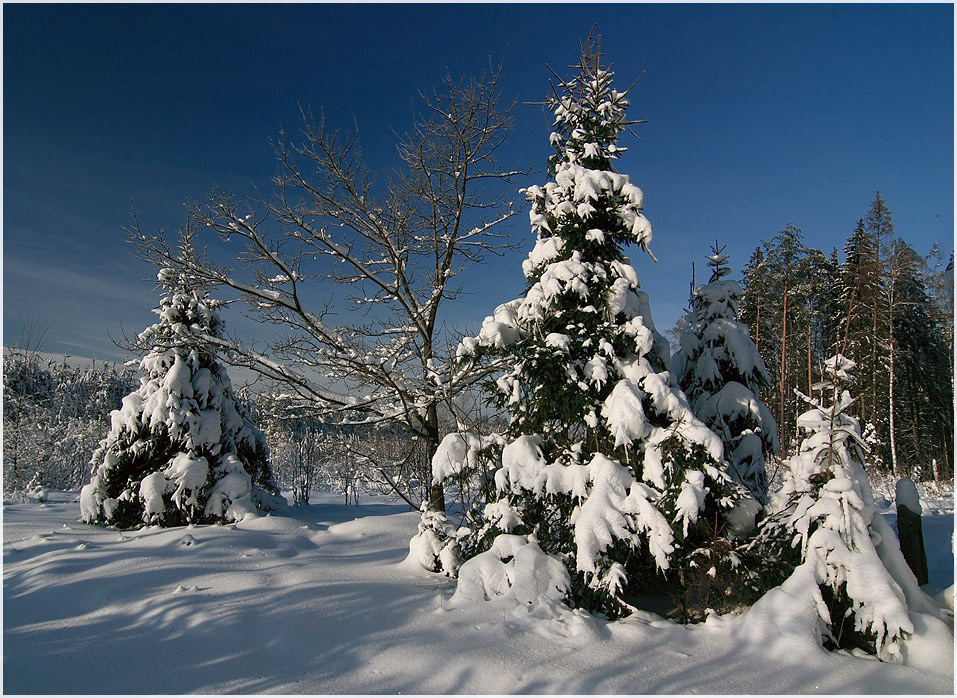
[746, 354, 933, 661]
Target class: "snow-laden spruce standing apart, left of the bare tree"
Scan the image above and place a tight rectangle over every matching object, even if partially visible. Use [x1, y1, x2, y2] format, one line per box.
[80, 250, 282, 528]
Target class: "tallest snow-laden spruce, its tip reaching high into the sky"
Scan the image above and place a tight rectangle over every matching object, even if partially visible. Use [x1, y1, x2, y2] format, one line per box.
[433, 42, 744, 617]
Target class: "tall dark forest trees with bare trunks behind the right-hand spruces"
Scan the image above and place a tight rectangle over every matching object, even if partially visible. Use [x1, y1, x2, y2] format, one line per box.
[739, 192, 954, 480]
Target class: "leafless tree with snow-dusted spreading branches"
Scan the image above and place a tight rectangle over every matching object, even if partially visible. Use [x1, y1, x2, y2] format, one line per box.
[132, 69, 524, 511]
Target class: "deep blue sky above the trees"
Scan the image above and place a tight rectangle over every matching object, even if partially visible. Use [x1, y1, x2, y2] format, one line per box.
[3, 4, 954, 359]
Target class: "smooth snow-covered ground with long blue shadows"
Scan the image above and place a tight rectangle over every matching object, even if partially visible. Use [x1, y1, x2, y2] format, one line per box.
[3, 492, 954, 694]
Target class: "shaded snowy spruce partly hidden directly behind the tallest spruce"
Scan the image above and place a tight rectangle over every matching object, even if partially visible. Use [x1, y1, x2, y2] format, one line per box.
[672, 242, 778, 503]
